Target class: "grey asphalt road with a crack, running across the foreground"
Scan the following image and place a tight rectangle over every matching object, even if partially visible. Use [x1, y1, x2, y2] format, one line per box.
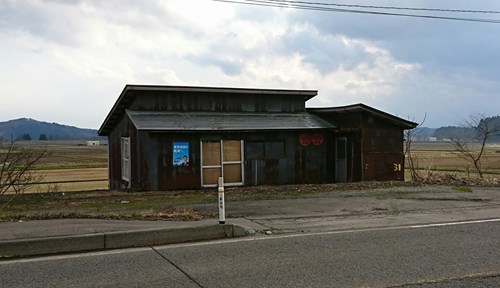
[0, 220, 500, 288]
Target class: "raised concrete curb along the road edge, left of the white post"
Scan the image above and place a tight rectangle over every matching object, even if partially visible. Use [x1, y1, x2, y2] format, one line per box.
[0, 224, 255, 259]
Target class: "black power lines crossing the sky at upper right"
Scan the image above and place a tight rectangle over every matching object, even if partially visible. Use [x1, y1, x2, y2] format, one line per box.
[213, 0, 500, 24]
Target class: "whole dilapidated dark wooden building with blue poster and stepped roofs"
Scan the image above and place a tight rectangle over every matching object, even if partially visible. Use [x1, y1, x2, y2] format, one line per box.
[99, 85, 417, 191]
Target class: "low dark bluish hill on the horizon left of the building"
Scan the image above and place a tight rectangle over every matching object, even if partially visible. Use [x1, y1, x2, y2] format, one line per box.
[0, 118, 99, 140]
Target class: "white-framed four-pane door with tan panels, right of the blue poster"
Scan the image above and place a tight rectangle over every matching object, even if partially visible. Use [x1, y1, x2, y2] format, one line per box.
[201, 140, 243, 187]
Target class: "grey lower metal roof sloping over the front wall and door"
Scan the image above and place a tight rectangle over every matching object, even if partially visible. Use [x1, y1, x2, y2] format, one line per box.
[126, 110, 335, 131]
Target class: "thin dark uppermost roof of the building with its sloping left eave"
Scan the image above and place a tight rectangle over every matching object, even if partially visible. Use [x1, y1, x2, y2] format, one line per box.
[98, 85, 318, 136]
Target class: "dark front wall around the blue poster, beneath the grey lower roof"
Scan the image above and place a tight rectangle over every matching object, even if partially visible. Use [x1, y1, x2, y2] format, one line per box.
[127, 131, 333, 190]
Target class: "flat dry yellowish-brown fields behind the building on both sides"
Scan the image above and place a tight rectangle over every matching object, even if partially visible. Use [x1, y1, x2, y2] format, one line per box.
[3, 141, 500, 193]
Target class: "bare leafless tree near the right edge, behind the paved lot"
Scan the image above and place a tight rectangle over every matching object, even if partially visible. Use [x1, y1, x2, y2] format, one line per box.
[451, 114, 500, 178]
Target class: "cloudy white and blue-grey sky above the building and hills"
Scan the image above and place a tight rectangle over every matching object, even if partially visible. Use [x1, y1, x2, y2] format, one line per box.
[0, 0, 500, 129]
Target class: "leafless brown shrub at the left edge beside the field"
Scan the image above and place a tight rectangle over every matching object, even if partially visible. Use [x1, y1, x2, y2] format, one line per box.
[0, 141, 47, 210]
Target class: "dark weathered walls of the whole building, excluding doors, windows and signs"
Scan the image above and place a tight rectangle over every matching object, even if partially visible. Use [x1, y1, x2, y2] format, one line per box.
[109, 104, 404, 191]
